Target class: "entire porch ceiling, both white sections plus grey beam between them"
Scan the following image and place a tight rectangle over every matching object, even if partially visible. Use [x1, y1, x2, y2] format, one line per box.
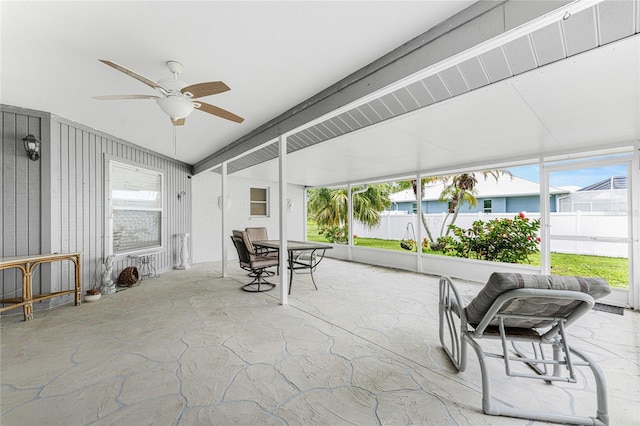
[0, 0, 640, 186]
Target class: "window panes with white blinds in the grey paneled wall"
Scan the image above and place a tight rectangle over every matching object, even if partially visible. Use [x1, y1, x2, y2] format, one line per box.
[109, 161, 163, 254]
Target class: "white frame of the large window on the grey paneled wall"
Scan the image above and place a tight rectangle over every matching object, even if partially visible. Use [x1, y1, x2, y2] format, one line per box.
[104, 156, 166, 257]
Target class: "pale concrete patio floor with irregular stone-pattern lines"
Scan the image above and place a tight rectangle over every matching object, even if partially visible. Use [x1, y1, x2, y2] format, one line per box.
[0, 259, 640, 426]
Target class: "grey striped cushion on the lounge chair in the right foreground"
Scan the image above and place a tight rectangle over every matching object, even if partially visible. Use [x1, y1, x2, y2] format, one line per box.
[465, 272, 611, 328]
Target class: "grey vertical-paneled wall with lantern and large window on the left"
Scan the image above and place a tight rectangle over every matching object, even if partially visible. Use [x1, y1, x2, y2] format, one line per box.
[0, 105, 191, 312]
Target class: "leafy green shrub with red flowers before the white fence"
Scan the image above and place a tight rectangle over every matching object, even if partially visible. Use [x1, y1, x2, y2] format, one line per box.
[438, 213, 540, 263]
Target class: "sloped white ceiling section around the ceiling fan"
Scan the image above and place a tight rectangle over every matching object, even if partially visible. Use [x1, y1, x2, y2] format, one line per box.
[0, 0, 473, 164]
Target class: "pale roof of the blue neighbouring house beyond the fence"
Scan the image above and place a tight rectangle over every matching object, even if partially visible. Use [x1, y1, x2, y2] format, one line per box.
[389, 175, 569, 203]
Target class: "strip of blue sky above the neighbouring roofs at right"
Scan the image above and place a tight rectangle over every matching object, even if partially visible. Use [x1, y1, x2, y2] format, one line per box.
[508, 164, 627, 188]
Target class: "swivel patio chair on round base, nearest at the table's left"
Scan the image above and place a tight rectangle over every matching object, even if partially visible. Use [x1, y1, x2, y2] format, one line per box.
[231, 230, 280, 292]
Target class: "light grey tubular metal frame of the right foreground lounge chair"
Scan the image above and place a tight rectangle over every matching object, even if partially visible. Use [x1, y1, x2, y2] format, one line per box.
[439, 276, 609, 425]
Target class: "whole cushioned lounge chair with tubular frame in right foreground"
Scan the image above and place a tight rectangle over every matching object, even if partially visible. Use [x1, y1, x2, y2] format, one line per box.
[439, 273, 611, 425]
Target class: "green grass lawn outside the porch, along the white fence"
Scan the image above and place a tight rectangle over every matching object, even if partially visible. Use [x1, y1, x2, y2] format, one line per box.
[307, 223, 629, 288]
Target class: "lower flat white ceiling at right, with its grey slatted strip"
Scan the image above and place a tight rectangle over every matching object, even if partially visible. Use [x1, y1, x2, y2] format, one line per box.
[228, 1, 640, 186]
